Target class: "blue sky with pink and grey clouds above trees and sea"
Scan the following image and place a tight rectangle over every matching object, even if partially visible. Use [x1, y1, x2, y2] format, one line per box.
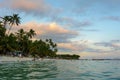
[0, 0, 120, 58]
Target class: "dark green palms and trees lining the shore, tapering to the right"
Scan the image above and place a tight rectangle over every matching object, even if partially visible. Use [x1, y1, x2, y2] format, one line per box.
[0, 14, 79, 59]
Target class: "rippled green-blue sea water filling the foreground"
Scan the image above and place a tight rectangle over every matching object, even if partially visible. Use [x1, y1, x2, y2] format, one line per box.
[0, 60, 120, 80]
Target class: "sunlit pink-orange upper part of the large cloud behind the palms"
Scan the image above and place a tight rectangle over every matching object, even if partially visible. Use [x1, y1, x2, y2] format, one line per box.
[21, 22, 78, 35]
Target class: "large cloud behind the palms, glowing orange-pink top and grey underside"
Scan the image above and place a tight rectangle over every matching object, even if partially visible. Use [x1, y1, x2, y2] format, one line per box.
[13, 22, 79, 43]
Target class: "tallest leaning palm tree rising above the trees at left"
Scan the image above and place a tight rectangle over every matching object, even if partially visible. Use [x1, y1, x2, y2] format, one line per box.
[8, 14, 20, 34]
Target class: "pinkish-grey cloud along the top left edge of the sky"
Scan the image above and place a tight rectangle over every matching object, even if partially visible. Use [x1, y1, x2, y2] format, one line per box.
[0, 0, 59, 17]
